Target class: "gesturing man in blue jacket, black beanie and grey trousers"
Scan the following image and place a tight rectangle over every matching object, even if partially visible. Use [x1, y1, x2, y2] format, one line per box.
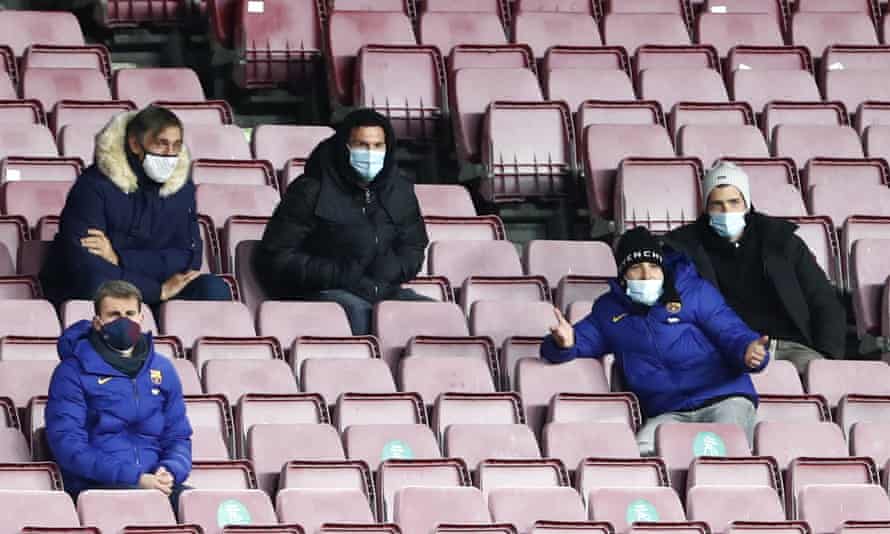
[541, 227, 769, 456]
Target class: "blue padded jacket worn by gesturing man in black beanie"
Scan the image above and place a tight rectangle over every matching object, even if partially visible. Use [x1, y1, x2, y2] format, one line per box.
[541, 254, 769, 417]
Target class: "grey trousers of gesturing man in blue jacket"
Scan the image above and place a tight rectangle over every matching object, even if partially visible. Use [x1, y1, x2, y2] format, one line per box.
[637, 397, 757, 456]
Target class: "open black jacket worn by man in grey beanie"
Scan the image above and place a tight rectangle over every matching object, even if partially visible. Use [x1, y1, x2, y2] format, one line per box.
[664, 211, 846, 358]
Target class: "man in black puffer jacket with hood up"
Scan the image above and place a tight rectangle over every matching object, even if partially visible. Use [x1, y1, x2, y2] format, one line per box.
[254, 109, 429, 335]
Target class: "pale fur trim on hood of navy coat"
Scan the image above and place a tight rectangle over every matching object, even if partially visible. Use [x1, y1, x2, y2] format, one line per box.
[95, 111, 191, 197]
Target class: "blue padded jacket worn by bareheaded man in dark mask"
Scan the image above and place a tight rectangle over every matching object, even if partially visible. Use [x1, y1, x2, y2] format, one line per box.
[45, 321, 192, 493]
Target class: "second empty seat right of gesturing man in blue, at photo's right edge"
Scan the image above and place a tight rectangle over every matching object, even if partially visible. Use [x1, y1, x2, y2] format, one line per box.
[807, 360, 890, 408]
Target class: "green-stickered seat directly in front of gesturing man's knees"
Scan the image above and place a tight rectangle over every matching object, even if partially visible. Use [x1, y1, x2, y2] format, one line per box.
[655, 423, 751, 491]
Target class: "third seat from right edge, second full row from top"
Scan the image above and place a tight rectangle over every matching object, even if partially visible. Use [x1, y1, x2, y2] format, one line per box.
[636, 45, 729, 111]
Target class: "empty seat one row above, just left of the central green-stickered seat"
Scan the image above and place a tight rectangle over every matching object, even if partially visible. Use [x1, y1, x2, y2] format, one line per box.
[299, 358, 396, 404]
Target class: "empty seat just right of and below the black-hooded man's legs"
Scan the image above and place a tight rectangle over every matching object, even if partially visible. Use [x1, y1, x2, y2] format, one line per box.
[374, 301, 469, 369]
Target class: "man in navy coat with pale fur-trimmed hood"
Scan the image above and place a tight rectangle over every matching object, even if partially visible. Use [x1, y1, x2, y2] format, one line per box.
[40, 106, 231, 306]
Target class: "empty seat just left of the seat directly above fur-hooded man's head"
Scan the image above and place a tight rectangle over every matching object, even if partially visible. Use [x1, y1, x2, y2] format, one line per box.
[22, 67, 111, 110]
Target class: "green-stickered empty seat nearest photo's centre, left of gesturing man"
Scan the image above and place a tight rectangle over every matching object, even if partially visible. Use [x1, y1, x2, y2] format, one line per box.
[343, 424, 442, 471]
